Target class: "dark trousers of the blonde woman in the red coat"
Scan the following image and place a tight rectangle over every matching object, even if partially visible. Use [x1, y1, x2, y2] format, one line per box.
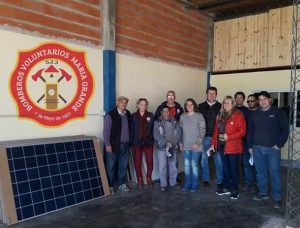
[219, 145, 240, 193]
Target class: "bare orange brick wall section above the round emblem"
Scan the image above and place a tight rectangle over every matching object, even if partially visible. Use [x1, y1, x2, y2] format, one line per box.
[0, 0, 102, 45]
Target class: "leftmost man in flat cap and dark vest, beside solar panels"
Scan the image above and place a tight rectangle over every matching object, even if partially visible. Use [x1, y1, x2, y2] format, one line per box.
[103, 96, 130, 194]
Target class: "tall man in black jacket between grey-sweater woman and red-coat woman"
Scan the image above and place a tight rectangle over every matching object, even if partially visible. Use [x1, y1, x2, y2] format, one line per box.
[199, 86, 223, 189]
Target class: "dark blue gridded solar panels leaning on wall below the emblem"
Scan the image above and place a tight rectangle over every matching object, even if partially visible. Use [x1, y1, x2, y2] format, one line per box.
[0, 137, 109, 224]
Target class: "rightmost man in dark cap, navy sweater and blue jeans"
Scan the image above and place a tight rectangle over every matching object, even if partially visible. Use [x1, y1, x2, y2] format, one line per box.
[247, 91, 289, 208]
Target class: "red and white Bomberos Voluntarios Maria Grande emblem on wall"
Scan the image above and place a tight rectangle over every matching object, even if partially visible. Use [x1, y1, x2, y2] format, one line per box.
[10, 43, 94, 126]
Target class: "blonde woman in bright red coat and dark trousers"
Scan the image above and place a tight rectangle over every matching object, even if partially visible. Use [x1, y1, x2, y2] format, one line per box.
[210, 96, 246, 199]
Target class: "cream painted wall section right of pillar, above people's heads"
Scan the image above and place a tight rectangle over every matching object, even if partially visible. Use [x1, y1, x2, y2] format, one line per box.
[116, 54, 207, 112]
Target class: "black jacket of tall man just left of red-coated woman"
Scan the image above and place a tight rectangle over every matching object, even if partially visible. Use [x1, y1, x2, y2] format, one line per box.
[199, 101, 222, 137]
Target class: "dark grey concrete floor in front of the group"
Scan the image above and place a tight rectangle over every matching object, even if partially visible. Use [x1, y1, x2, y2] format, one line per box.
[0, 169, 286, 228]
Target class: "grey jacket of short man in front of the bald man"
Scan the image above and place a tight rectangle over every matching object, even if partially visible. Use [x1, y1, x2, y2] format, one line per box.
[153, 117, 182, 149]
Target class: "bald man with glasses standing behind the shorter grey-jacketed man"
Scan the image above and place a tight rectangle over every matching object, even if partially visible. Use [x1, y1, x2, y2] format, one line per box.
[155, 90, 183, 120]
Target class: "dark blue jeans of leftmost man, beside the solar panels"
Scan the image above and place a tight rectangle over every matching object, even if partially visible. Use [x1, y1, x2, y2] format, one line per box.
[105, 143, 129, 187]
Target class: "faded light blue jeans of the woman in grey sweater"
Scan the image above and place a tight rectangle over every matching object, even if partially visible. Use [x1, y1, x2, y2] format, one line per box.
[183, 150, 201, 190]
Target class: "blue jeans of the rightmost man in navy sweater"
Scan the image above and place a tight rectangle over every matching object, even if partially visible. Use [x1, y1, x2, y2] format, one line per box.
[253, 145, 281, 201]
